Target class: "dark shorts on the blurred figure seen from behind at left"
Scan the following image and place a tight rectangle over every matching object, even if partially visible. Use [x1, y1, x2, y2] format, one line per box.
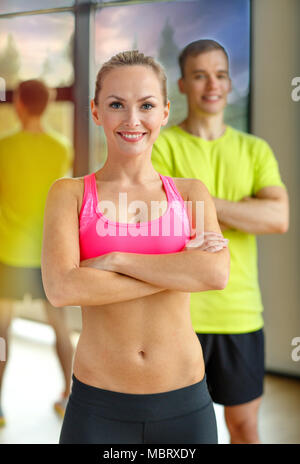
[0, 262, 47, 300]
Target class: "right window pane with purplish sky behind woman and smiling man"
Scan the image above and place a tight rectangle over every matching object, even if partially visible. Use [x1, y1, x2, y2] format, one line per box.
[90, 0, 250, 170]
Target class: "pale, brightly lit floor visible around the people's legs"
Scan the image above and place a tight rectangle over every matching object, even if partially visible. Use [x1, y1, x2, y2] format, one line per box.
[0, 319, 300, 444]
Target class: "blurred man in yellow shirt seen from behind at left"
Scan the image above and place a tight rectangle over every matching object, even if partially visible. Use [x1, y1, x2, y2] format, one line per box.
[0, 80, 73, 426]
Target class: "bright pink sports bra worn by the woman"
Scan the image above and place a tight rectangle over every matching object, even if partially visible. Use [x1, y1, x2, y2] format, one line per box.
[79, 173, 191, 261]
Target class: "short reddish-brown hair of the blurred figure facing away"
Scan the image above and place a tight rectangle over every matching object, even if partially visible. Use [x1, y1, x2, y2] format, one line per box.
[15, 79, 50, 116]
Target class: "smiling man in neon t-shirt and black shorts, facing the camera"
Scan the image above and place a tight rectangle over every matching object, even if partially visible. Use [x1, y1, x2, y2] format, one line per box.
[152, 40, 288, 443]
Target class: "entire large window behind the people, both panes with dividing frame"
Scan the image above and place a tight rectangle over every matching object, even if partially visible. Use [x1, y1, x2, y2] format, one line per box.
[0, 0, 250, 317]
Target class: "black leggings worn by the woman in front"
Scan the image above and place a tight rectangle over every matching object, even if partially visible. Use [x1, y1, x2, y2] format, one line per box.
[59, 375, 218, 444]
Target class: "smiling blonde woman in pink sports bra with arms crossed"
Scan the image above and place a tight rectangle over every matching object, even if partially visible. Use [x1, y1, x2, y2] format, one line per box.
[42, 51, 229, 444]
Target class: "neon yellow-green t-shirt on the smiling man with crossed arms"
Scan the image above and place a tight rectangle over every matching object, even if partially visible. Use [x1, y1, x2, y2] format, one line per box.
[152, 126, 284, 333]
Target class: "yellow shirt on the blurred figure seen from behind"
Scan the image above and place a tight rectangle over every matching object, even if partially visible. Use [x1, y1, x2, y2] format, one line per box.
[0, 131, 72, 267]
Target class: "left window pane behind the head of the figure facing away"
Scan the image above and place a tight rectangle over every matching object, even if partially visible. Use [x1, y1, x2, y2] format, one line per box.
[0, 11, 74, 142]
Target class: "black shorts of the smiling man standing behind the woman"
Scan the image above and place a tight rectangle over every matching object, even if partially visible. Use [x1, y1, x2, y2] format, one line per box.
[197, 329, 264, 406]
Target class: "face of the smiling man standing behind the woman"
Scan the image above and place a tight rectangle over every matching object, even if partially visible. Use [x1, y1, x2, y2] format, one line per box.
[178, 50, 231, 115]
